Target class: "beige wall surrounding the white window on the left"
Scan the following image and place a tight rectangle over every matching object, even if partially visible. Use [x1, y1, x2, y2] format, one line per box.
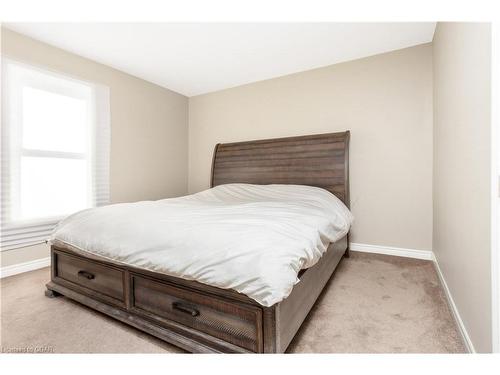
[1, 28, 188, 266]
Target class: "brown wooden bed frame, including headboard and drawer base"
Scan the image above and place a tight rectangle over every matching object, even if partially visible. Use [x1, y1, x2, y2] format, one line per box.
[45, 131, 349, 353]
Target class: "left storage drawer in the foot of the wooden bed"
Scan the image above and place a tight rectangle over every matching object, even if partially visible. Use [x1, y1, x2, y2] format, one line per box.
[55, 252, 125, 302]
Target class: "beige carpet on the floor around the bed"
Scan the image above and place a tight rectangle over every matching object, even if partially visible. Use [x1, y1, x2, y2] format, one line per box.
[0, 253, 464, 353]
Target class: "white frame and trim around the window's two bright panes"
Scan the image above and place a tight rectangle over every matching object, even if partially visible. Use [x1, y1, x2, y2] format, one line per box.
[1, 57, 110, 251]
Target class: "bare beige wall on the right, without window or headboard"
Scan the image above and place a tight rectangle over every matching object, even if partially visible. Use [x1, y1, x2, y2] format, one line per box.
[433, 23, 492, 352]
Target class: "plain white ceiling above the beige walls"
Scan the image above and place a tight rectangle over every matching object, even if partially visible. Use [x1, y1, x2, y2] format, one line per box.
[5, 22, 435, 96]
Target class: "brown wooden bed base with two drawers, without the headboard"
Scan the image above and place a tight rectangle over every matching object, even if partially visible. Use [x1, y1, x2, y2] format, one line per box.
[45, 237, 347, 353]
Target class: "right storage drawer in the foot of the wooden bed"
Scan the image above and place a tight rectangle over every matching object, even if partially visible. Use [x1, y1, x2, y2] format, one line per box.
[131, 274, 262, 352]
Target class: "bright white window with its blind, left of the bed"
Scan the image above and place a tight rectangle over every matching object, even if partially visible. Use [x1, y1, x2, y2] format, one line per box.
[1, 59, 109, 250]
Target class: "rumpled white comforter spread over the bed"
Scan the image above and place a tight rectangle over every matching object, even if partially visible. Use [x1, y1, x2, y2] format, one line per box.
[52, 184, 353, 306]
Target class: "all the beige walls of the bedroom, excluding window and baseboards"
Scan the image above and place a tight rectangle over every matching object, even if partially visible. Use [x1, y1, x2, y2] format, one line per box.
[2, 23, 491, 351]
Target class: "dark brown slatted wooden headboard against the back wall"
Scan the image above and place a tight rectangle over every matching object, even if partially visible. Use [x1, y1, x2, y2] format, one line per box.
[210, 131, 350, 207]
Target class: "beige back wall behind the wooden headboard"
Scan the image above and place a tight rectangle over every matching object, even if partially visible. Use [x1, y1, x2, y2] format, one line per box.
[189, 44, 432, 250]
